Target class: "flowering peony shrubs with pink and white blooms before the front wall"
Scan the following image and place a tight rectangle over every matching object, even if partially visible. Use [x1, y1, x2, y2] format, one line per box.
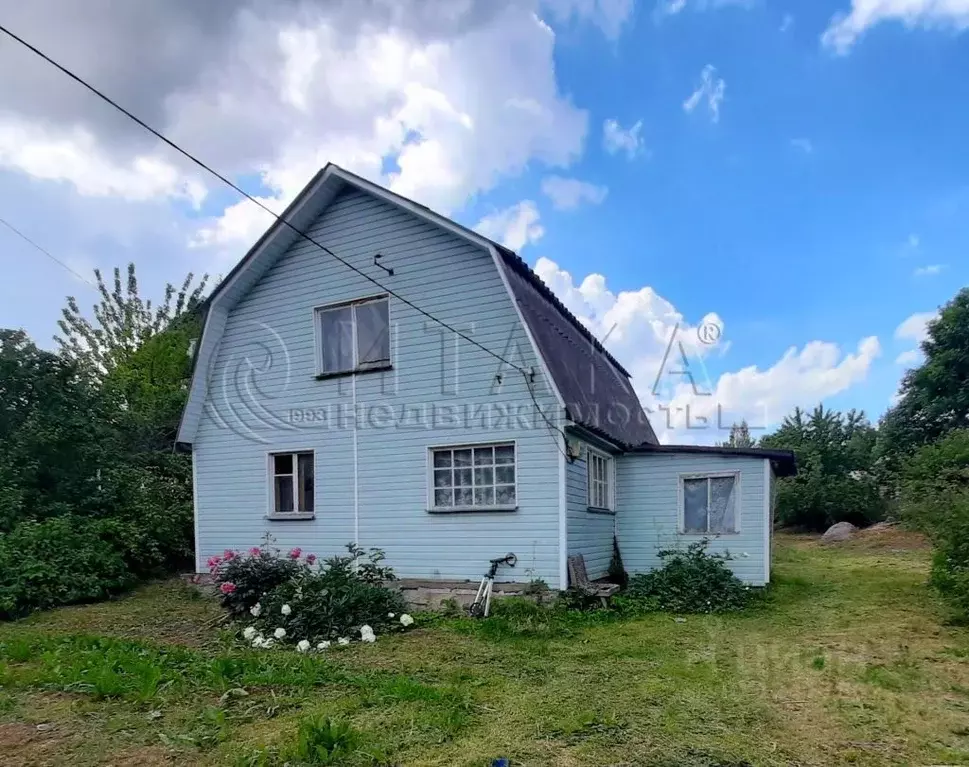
[210, 544, 406, 643]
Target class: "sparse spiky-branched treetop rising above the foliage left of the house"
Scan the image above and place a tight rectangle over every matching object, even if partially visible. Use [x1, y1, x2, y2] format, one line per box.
[54, 263, 208, 377]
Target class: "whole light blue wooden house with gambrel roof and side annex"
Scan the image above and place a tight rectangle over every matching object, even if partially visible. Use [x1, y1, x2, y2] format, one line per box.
[178, 165, 794, 589]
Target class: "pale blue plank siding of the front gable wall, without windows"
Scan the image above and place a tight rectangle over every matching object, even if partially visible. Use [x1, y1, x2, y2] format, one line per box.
[194, 191, 560, 587]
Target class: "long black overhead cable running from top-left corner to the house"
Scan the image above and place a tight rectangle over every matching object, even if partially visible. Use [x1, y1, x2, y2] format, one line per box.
[0, 25, 528, 375]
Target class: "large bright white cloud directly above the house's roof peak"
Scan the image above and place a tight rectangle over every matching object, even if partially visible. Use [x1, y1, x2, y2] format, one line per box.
[187, 6, 586, 246]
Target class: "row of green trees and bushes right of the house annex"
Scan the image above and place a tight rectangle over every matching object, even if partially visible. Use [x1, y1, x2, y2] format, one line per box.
[726, 288, 969, 614]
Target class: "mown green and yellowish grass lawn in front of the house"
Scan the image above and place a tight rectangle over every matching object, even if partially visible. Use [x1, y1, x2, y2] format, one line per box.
[0, 533, 969, 767]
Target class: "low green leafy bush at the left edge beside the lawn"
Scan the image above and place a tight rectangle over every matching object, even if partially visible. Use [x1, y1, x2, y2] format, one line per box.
[0, 516, 135, 618]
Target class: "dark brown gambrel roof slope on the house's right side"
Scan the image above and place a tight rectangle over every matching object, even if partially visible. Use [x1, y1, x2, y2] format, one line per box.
[498, 246, 657, 447]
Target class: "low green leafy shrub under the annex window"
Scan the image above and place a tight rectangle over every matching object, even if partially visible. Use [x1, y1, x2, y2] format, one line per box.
[617, 540, 759, 613]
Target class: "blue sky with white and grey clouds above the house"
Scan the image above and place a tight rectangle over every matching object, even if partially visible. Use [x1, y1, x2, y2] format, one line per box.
[0, 0, 969, 441]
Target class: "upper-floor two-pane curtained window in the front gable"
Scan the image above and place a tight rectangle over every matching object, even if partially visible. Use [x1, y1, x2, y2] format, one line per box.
[316, 297, 390, 375]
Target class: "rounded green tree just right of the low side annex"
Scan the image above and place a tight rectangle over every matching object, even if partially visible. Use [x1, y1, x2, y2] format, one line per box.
[761, 405, 885, 530]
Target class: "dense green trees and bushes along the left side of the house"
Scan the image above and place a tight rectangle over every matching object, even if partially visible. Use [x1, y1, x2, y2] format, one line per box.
[0, 264, 207, 617]
